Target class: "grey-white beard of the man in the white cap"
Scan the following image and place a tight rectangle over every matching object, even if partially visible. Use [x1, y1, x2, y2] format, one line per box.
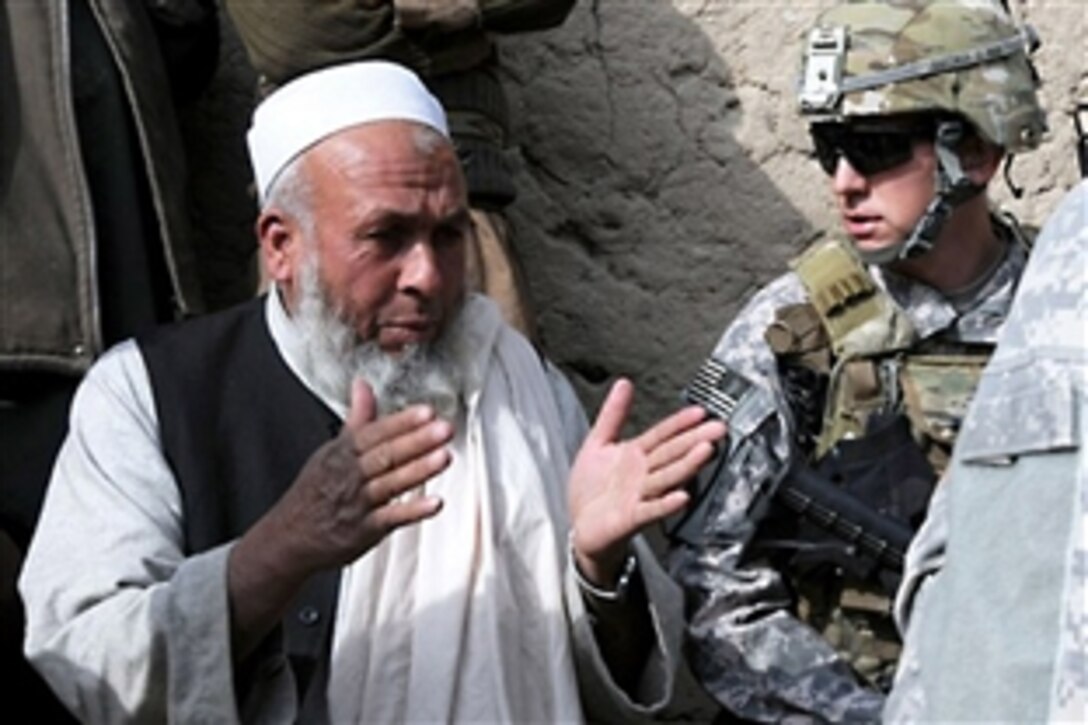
[293, 251, 463, 420]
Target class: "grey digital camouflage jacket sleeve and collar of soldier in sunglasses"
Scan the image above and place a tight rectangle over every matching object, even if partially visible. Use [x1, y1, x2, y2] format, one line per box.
[668, 223, 1026, 723]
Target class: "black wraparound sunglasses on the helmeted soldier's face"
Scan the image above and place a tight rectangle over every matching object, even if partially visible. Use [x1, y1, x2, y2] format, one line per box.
[809, 123, 934, 176]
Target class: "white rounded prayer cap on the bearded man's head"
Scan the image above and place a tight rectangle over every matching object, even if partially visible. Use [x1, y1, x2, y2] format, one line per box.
[246, 60, 449, 204]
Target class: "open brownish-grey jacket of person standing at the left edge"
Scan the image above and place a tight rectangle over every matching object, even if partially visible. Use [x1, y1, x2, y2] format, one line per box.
[0, 0, 207, 374]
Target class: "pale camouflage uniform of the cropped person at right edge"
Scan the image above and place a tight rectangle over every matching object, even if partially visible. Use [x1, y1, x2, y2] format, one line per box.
[886, 177, 1088, 723]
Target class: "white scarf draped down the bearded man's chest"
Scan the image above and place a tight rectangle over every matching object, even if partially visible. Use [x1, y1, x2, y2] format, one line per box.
[329, 298, 582, 724]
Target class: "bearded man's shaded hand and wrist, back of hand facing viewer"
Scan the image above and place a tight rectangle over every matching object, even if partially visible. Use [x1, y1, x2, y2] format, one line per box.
[227, 381, 454, 660]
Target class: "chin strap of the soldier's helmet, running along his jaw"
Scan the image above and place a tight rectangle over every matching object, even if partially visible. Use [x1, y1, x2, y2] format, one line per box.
[860, 120, 986, 265]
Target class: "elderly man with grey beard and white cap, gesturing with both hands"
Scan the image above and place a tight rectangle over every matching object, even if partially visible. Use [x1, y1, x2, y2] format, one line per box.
[21, 61, 724, 723]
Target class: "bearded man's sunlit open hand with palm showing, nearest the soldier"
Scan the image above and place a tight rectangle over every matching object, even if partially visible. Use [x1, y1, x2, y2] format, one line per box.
[568, 379, 726, 588]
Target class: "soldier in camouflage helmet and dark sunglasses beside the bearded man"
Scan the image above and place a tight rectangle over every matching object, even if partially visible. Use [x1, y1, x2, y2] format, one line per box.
[669, 0, 1046, 722]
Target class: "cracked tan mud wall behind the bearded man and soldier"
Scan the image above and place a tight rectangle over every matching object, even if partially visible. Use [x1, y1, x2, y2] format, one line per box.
[191, 0, 1088, 426]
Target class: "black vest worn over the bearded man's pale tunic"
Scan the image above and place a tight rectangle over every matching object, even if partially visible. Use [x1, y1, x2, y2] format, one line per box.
[139, 297, 341, 722]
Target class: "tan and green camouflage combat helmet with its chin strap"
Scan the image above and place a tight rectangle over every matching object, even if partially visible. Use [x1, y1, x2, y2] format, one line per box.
[799, 0, 1047, 261]
